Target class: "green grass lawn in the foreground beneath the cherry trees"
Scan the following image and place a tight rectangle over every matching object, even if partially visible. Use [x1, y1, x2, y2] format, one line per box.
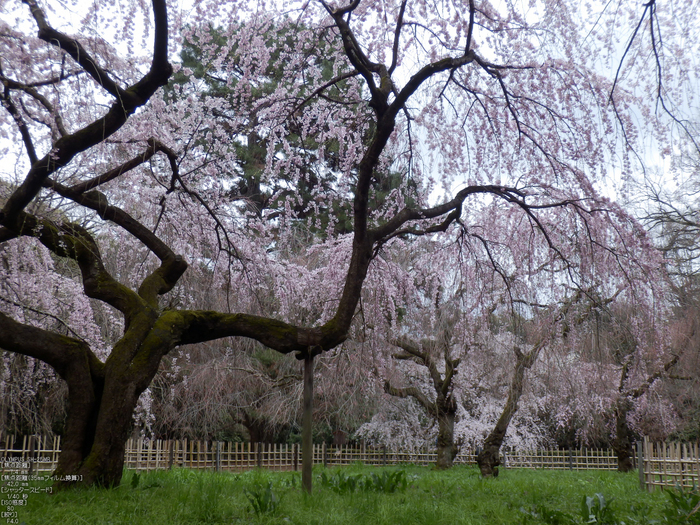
[15, 465, 669, 525]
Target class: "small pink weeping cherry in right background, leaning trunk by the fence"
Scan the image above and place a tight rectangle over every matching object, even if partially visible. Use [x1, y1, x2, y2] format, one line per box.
[540, 293, 694, 472]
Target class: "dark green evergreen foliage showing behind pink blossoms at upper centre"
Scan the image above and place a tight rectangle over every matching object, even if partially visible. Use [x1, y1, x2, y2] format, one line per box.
[166, 25, 417, 238]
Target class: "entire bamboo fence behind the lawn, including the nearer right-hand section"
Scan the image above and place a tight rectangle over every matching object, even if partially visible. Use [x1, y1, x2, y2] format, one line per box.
[0, 435, 700, 491]
